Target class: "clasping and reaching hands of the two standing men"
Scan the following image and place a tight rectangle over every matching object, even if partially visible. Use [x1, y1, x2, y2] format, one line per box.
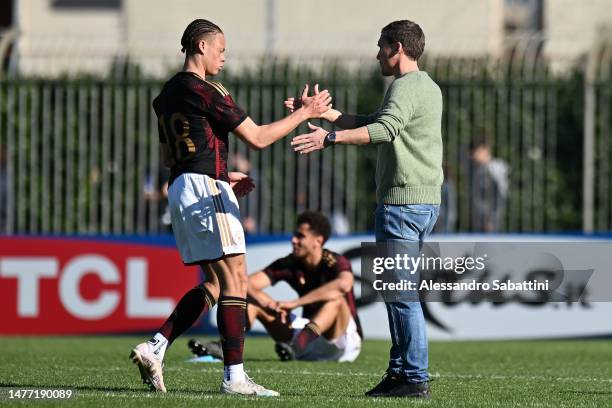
[284, 84, 340, 154]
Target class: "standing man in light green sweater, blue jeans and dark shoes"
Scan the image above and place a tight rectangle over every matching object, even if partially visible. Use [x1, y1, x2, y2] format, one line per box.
[285, 20, 444, 398]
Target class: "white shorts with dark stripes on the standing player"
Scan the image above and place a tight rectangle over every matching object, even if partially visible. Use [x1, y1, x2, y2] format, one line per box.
[168, 173, 245, 264]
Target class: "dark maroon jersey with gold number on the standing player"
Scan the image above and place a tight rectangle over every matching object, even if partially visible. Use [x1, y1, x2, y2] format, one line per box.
[153, 72, 247, 184]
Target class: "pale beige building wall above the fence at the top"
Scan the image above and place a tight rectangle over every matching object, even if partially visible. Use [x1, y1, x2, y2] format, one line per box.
[13, 0, 612, 74]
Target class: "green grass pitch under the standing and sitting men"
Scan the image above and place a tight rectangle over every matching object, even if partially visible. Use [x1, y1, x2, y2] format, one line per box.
[0, 337, 612, 408]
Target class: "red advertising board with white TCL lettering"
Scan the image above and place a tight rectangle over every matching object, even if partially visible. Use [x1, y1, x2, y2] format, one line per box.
[0, 238, 199, 334]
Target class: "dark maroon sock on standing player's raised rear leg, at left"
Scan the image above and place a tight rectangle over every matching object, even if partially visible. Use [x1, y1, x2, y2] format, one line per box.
[158, 284, 215, 351]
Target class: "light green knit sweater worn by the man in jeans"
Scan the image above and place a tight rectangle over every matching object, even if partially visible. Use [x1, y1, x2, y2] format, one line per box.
[358, 71, 444, 205]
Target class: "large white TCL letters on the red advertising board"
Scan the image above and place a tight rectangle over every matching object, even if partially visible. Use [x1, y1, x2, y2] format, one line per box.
[0, 255, 174, 320]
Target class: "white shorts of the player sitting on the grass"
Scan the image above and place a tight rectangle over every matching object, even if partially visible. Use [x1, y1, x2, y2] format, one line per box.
[291, 317, 361, 363]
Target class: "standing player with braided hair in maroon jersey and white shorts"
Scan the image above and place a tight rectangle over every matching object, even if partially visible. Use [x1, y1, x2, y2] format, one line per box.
[130, 19, 331, 396]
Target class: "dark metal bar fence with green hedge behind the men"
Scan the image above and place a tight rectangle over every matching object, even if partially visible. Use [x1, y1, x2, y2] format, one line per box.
[0, 53, 612, 234]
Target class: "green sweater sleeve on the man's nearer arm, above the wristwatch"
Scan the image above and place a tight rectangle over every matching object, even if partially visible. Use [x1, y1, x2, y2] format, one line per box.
[367, 82, 414, 144]
